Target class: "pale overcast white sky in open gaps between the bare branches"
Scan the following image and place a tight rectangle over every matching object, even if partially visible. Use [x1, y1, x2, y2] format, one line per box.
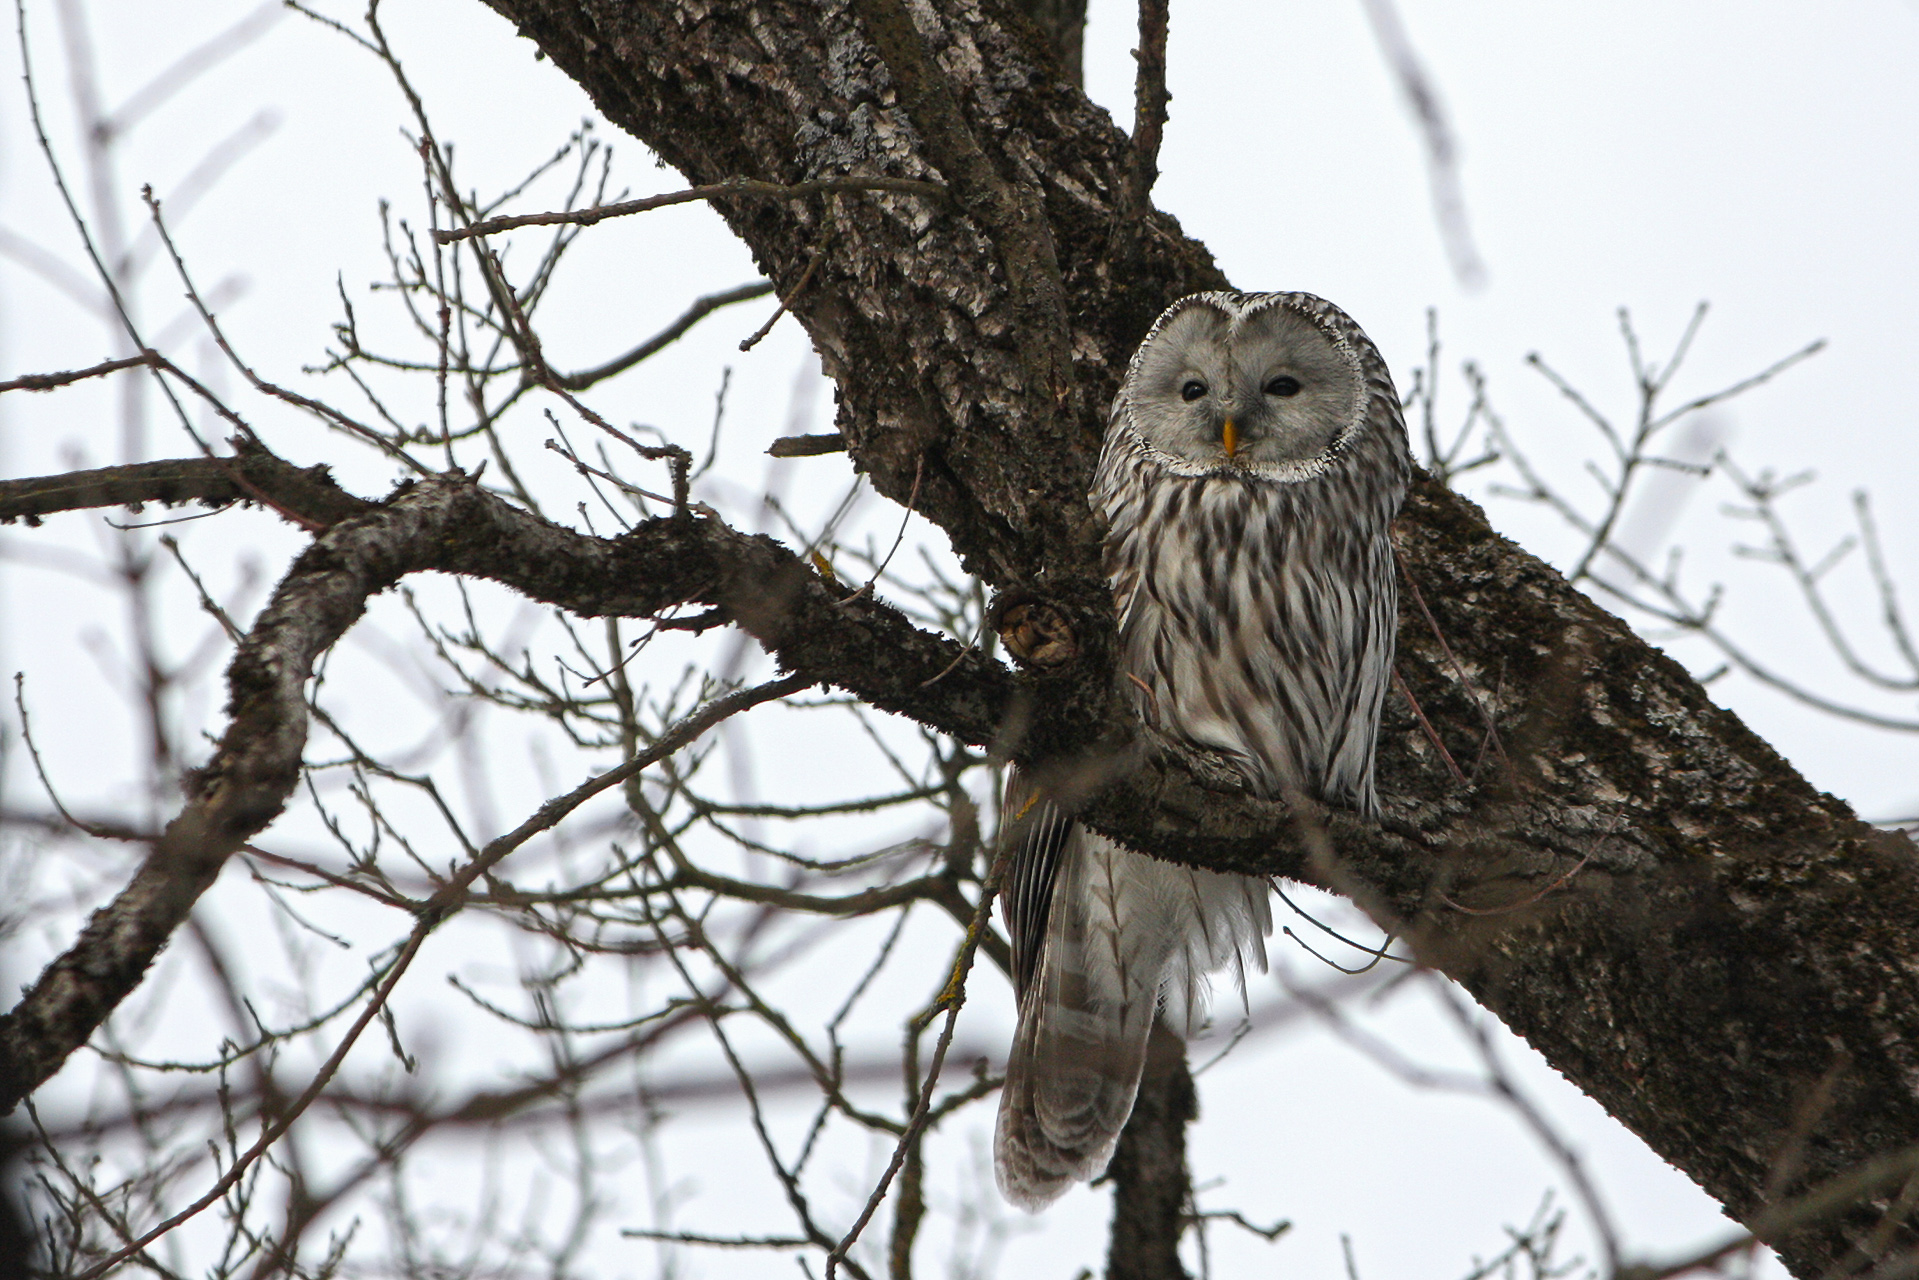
[0, 0, 1919, 1280]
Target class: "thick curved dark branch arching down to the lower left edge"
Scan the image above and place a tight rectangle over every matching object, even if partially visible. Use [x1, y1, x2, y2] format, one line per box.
[0, 475, 1013, 1109]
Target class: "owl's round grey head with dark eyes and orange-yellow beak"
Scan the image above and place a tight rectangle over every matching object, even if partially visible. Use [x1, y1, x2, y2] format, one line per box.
[1115, 292, 1376, 482]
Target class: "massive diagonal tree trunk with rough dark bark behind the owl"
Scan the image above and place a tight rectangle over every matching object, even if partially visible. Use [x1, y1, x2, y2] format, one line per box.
[456, 0, 1919, 1274]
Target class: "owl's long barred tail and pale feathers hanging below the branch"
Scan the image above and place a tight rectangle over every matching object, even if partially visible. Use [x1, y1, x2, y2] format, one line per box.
[994, 829, 1272, 1211]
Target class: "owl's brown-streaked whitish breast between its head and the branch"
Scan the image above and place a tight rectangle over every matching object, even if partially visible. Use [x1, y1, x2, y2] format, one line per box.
[1094, 432, 1397, 810]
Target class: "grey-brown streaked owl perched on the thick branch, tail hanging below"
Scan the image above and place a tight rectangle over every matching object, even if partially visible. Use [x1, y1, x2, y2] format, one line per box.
[994, 292, 1410, 1211]
